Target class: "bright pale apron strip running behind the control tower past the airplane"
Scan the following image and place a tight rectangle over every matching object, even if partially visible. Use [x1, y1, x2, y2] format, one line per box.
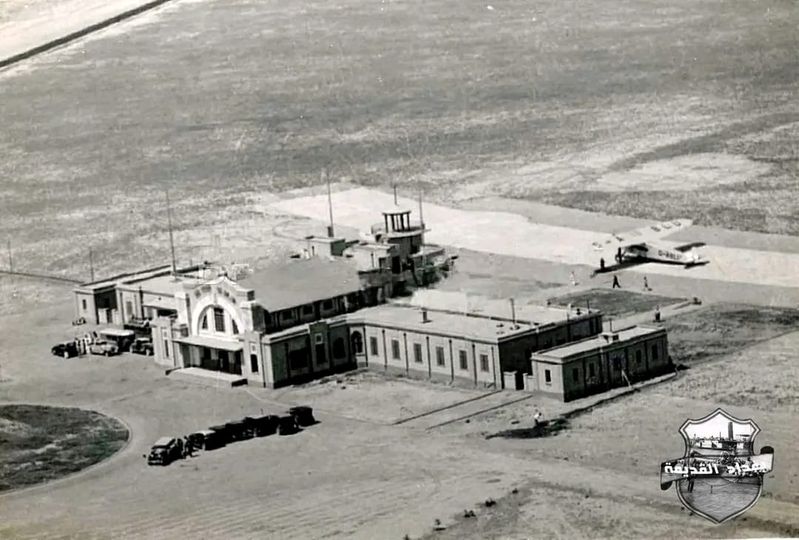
[274, 188, 799, 287]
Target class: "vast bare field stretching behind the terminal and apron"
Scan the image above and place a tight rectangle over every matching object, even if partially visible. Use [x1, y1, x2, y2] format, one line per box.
[0, 0, 799, 286]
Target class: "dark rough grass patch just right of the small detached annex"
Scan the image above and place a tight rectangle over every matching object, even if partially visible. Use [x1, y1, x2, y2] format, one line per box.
[664, 304, 799, 365]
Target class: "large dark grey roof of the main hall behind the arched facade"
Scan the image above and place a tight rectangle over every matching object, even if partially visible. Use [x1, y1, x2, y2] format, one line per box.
[238, 257, 361, 312]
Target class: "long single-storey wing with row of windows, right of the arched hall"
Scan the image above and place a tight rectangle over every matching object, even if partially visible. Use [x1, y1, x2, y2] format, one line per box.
[347, 301, 602, 389]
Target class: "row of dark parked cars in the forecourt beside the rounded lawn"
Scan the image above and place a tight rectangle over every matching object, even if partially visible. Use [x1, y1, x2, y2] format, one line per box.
[145, 406, 317, 466]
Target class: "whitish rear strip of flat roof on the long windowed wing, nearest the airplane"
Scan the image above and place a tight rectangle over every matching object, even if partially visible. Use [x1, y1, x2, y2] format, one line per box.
[398, 289, 599, 326]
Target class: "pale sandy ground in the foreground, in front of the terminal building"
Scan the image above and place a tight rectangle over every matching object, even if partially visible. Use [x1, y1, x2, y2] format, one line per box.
[0, 298, 799, 538]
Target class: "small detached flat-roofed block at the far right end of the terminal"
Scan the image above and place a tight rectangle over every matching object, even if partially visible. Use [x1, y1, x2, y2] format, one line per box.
[526, 326, 672, 401]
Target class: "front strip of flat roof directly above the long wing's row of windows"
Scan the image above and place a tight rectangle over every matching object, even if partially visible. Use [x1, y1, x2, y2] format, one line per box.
[348, 304, 534, 342]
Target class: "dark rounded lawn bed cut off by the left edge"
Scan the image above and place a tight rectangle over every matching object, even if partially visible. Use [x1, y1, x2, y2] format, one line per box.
[0, 405, 129, 492]
